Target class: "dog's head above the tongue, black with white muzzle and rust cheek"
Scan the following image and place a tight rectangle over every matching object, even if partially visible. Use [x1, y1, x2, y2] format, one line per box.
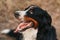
[14, 5, 52, 32]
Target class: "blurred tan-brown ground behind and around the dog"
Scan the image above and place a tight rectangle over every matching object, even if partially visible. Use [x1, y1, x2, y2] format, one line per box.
[0, 0, 60, 40]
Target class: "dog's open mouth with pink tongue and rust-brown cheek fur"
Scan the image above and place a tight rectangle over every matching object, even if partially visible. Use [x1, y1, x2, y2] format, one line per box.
[14, 17, 38, 32]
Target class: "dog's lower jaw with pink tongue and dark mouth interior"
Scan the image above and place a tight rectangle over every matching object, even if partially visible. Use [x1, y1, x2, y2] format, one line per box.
[14, 21, 33, 33]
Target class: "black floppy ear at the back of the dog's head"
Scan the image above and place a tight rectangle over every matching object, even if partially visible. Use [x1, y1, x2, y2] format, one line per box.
[40, 10, 52, 25]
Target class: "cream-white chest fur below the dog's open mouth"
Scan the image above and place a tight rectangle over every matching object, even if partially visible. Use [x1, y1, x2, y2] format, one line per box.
[22, 28, 37, 40]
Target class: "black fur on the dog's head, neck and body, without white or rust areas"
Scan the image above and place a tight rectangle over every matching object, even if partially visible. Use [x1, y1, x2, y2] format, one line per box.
[3, 5, 57, 40]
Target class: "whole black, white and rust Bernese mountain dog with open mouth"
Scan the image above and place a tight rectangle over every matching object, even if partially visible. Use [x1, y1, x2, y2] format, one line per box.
[1, 5, 57, 40]
